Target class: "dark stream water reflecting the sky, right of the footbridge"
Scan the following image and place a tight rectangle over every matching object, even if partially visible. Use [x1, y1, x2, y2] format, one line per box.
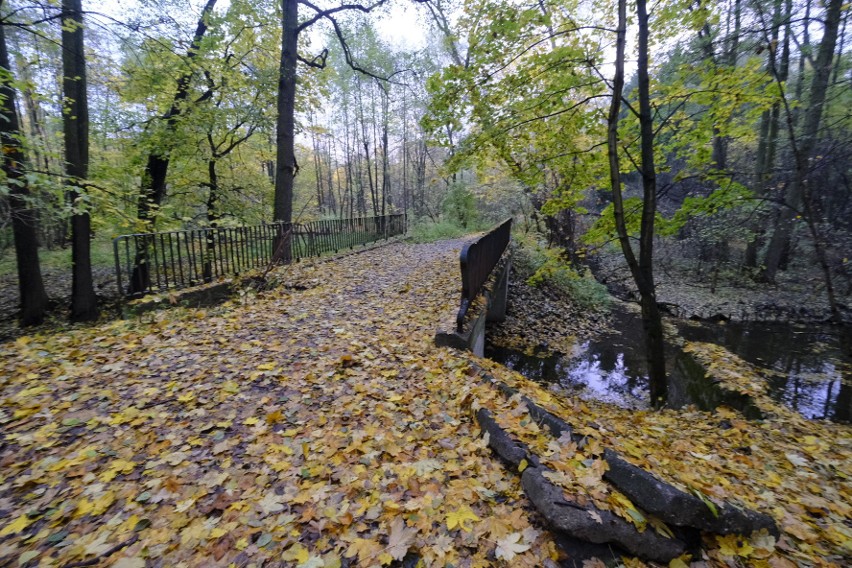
[485, 310, 852, 422]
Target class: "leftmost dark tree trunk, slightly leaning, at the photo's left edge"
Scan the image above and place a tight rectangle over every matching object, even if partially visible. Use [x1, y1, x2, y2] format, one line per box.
[0, 15, 47, 326]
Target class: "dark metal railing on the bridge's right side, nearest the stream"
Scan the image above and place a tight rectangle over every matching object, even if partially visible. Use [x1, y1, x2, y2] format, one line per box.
[456, 219, 512, 333]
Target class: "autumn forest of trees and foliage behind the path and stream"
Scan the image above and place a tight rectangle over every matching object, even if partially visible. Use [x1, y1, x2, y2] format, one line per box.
[0, 0, 852, 332]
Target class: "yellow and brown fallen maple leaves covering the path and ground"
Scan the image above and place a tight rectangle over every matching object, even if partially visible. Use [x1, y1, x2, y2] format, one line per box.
[0, 237, 852, 567]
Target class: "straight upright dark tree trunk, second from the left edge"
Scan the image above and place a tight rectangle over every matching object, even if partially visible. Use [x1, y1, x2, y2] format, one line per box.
[62, 0, 98, 321]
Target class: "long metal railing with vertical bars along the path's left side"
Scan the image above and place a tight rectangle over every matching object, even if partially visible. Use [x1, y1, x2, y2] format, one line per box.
[113, 214, 406, 298]
